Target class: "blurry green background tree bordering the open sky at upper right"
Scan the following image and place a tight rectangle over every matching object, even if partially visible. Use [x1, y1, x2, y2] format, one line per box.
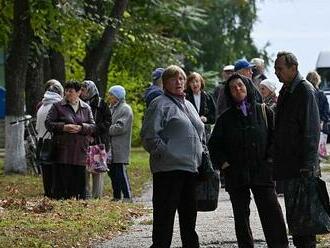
[184, 0, 268, 71]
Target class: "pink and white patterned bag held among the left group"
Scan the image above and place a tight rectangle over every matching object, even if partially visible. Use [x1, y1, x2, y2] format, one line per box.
[86, 144, 109, 173]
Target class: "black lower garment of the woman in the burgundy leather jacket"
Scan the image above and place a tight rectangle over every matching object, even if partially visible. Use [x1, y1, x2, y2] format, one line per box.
[53, 164, 86, 199]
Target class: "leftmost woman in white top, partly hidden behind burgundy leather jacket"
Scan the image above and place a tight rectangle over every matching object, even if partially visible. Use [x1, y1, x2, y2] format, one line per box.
[36, 79, 64, 198]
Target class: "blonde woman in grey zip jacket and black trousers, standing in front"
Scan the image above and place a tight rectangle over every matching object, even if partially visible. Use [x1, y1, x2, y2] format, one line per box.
[141, 65, 205, 248]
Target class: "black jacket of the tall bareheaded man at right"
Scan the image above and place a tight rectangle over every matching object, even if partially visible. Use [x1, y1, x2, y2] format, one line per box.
[274, 73, 320, 179]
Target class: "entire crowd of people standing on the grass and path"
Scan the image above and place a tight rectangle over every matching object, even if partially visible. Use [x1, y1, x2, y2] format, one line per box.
[37, 49, 330, 248]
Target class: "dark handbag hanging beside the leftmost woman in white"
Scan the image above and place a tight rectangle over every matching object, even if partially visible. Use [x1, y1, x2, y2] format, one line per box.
[36, 130, 54, 164]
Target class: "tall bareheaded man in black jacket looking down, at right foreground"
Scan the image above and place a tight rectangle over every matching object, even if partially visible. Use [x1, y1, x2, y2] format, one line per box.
[274, 52, 320, 248]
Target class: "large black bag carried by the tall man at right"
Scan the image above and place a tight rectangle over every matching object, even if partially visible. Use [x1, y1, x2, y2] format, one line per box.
[285, 176, 330, 236]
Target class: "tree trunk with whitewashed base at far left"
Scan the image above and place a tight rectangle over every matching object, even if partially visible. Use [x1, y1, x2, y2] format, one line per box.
[5, 0, 31, 173]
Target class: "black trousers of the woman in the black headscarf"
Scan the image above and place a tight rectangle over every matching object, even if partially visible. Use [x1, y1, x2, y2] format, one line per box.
[229, 186, 288, 248]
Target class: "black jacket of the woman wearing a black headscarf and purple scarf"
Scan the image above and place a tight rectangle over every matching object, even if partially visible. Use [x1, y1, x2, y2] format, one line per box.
[208, 74, 274, 191]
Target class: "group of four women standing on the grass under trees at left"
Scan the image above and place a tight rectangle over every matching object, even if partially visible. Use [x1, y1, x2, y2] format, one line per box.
[36, 79, 133, 202]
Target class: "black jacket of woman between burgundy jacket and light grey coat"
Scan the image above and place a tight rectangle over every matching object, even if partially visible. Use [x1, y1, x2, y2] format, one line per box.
[89, 96, 111, 151]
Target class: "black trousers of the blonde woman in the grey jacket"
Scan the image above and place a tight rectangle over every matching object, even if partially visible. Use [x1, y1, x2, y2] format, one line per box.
[151, 171, 199, 248]
